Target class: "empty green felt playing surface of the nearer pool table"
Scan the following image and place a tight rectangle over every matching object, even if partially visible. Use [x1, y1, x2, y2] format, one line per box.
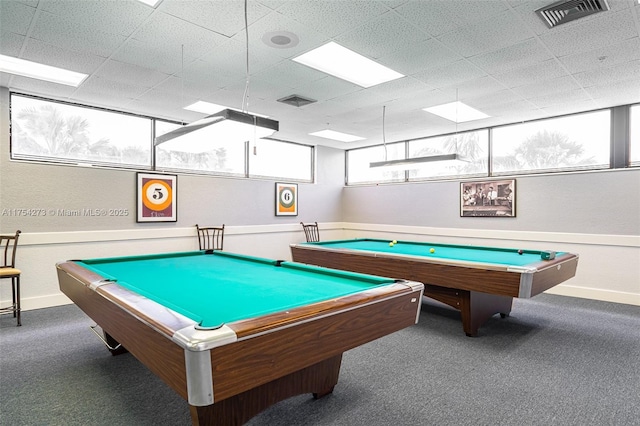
[78, 251, 394, 327]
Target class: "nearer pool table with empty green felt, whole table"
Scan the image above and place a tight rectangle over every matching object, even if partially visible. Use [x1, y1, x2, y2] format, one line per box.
[56, 251, 423, 425]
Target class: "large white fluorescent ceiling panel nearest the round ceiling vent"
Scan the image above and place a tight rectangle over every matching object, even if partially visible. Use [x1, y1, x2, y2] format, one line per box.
[293, 41, 404, 87]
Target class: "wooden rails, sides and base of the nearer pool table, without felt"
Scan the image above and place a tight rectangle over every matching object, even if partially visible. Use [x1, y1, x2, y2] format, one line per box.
[57, 262, 423, 424]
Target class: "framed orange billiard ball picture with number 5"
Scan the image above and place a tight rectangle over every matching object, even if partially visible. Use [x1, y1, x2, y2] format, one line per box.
[136, 172, 178, 222]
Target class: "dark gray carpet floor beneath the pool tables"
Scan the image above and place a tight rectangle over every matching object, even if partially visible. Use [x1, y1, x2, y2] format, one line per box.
[0, 294, 640, 426]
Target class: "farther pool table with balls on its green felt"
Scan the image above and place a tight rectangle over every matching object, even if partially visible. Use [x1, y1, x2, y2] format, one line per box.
[291, 238, 578, 336]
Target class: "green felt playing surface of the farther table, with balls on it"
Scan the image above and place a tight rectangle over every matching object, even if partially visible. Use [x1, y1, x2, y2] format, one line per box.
[307, 238, 562, 266]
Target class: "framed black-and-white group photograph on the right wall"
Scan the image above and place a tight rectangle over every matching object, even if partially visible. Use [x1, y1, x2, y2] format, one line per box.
[460, 179, 516, 217]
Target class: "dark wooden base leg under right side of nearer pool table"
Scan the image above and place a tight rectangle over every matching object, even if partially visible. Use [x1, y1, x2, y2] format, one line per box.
[189, 354, 342, 426]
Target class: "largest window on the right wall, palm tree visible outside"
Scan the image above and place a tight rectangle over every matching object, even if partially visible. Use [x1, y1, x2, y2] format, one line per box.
[491, 110, 611, 174]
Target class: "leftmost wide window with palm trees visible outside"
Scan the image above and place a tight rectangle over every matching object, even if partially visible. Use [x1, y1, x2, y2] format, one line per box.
[11, 93, 151, 167]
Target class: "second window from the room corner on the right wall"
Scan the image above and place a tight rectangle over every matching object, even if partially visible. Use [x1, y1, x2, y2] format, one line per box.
[409, 129, 489, 179]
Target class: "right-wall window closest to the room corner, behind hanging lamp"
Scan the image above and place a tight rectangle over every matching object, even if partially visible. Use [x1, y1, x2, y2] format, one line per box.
[347, 142, 405, 184]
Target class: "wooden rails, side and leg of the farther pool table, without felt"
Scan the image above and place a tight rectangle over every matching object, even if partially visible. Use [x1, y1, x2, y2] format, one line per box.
[291, 244, 578, 336]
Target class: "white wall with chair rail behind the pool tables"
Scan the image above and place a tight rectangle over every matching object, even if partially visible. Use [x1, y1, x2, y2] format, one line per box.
[0, 88, 640, 310]
